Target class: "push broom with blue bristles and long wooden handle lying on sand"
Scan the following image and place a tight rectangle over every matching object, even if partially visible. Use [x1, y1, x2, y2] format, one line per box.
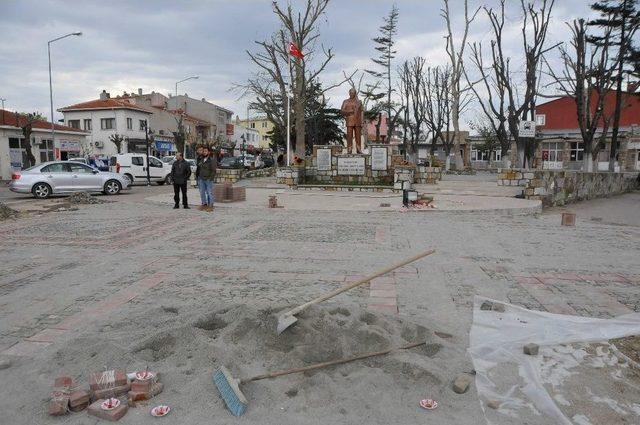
[213, 341, 426, 416]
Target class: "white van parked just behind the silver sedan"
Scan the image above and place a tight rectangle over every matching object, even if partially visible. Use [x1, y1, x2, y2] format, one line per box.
[109, 153, 172, 184]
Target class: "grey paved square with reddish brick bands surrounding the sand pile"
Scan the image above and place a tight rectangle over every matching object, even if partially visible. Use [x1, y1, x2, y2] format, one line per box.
[0, 183, 640, 424]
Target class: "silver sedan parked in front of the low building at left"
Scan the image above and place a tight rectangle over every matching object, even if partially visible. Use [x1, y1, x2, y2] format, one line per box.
[9, 161, 130, 199]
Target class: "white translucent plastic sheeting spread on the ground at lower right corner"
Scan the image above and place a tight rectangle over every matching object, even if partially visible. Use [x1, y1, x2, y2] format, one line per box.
[469, 297, 640, 425]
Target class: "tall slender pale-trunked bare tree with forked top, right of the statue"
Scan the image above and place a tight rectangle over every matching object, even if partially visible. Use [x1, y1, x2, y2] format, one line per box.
[440, 0, 480, 170]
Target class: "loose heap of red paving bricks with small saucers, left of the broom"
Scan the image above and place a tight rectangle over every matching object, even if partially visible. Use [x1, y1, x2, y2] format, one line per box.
[49, 370, 164, 421]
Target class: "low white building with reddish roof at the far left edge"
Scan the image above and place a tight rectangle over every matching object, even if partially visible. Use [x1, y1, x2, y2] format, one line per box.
[0, 109, 89, 180]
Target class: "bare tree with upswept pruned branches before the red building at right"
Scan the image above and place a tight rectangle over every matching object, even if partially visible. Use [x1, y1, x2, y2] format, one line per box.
[545, 19, 615, 172]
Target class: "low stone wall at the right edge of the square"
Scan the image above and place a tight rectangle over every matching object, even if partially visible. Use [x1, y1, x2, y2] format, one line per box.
[498, 170, 640, 206]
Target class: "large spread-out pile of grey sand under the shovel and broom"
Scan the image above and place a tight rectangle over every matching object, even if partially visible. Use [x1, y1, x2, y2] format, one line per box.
[31, 305, 452, 424]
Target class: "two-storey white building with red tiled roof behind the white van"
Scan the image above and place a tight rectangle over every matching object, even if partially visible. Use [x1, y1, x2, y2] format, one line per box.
[58, 90, 151, 156]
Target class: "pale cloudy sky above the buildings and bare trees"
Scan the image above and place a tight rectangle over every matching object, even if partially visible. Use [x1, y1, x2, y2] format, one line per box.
[0, 0, 590, 127]
